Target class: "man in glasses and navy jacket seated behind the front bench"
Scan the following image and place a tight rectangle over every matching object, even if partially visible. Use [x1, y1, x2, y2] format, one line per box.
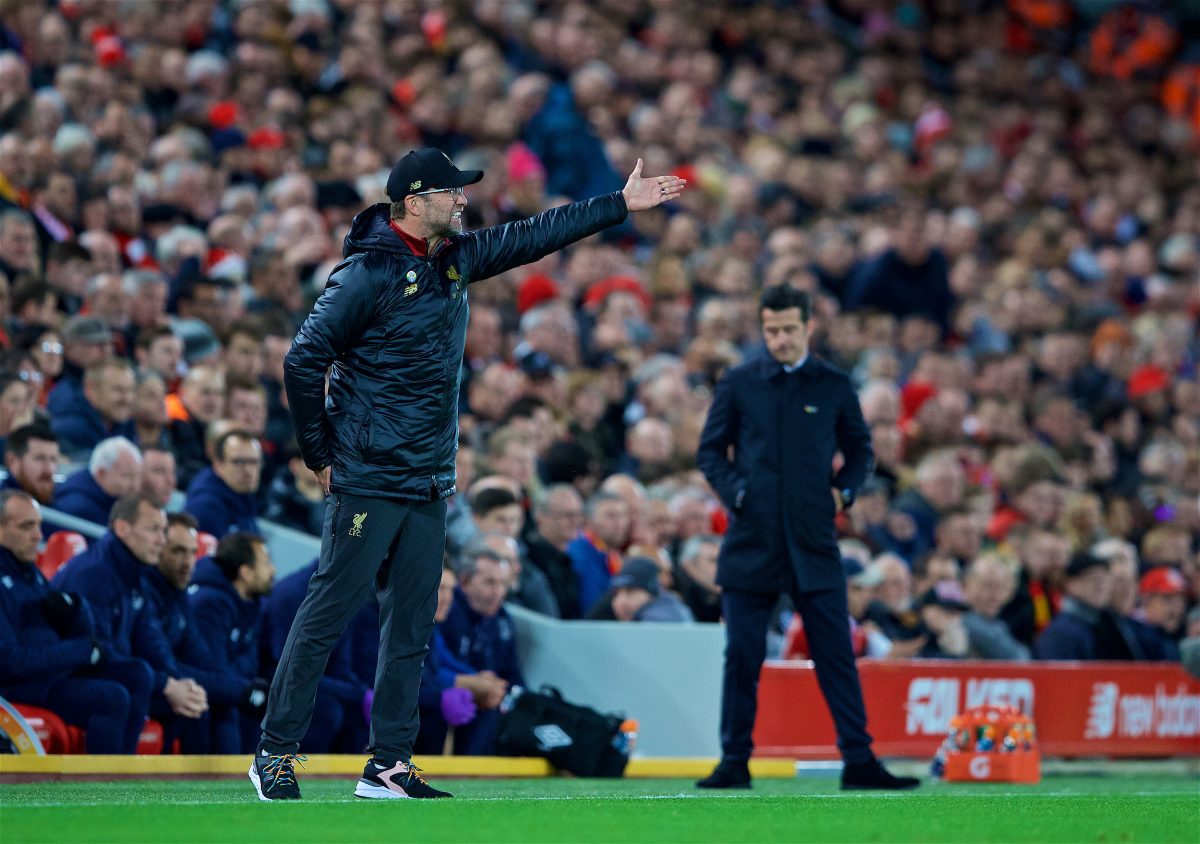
[184, 429, 263, 539]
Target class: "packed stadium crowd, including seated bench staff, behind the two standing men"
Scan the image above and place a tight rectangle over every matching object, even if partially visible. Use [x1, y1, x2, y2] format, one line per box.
[0, 0, 1200, 753]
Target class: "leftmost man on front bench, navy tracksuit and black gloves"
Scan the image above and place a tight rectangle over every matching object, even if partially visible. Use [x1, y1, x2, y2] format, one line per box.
[0, 490, 154, 754]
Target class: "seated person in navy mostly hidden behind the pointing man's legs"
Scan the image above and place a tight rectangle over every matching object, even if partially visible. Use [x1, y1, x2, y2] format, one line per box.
[263, 559, 369, 753]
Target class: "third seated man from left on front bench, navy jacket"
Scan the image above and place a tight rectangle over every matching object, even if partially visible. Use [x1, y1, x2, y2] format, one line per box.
[142, 513, 268, 754]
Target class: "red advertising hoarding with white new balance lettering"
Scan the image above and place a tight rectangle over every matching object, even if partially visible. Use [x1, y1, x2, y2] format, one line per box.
[754, 659, 1200, 759]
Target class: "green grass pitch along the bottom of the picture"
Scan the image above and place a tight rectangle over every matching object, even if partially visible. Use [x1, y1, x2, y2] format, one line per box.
[0, 776, 1200, 844]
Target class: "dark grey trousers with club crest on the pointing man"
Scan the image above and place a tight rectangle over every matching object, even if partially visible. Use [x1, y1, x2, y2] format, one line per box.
[260, 492, 446, 762]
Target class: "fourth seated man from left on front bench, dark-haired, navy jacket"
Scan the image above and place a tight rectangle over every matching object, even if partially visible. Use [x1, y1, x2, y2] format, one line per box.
[187, 533, 275, 753]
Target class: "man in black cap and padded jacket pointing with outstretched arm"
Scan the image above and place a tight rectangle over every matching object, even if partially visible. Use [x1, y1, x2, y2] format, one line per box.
[250, 149, 684, 800]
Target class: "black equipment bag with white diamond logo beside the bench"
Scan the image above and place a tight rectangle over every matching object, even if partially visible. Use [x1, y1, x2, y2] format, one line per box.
[496, 686, 629, 777]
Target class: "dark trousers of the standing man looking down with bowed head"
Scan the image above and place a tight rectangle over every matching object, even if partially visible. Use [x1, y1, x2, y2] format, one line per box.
[721, 588, 874, 764]
